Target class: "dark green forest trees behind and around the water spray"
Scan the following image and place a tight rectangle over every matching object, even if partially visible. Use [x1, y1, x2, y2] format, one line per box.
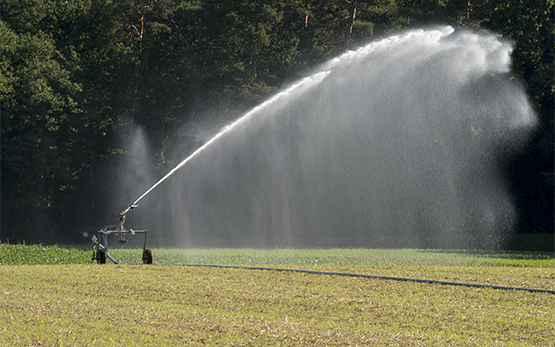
[0, 0, 555, 243]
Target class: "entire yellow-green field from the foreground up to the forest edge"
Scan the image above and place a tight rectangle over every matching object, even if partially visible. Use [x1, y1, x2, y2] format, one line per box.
[0, 244, 555, 346]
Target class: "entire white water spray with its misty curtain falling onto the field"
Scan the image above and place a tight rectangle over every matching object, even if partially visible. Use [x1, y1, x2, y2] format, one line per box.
[106, 27, 536, 248]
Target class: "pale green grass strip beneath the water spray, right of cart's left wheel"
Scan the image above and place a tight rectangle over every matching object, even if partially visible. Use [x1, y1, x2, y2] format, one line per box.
[110, 248, 555, 267]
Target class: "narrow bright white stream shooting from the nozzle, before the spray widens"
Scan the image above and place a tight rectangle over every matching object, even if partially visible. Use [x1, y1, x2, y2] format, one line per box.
[129, 70, 331, 206]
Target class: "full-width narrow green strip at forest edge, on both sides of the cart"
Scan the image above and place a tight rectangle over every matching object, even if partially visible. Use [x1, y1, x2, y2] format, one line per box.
[0, 243, 555, 267]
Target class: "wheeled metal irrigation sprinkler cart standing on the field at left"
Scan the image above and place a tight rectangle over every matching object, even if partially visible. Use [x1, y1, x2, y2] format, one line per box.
[91, 204, 152, 264]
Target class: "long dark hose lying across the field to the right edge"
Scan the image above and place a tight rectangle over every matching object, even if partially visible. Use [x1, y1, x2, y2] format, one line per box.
[185, 265, 555, 294]
